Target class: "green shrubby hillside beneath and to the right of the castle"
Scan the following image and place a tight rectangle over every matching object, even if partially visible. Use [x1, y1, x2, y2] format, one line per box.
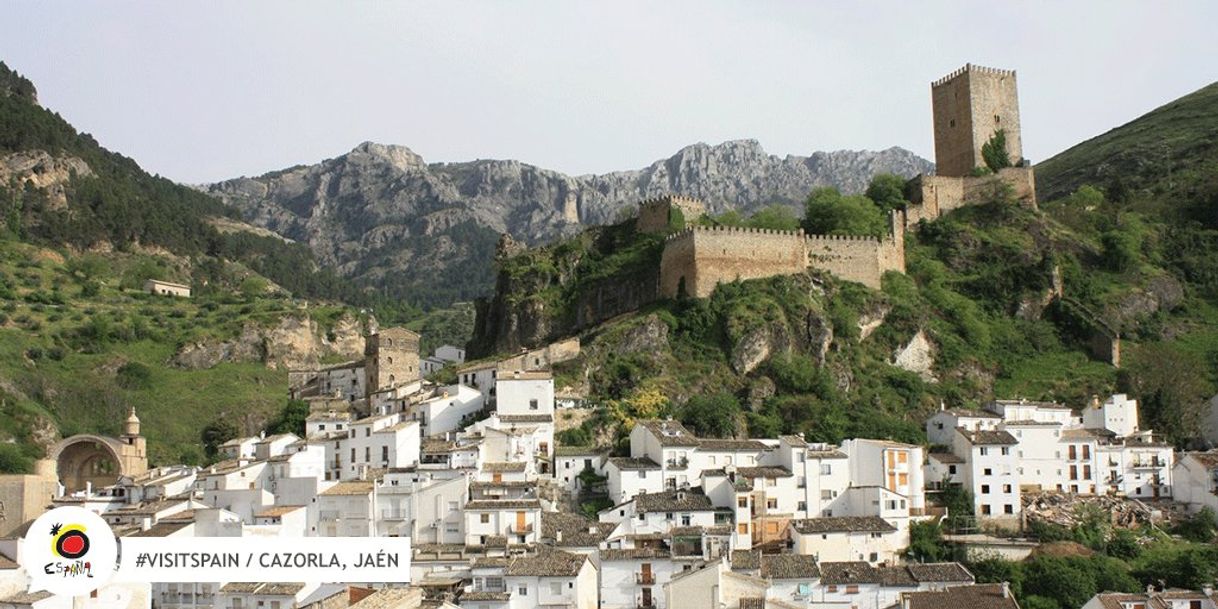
[489, 86, 1218, 453]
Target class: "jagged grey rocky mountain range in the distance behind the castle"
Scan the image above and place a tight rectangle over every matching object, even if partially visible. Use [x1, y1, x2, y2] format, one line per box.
[206, 140, 932, 306]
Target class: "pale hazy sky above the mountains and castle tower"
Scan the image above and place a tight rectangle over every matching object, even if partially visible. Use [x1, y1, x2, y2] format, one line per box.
[0, 0, 1218, 183]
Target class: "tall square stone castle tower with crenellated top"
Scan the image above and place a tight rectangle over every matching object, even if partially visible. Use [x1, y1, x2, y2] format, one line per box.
[931, 63, 1023, 177]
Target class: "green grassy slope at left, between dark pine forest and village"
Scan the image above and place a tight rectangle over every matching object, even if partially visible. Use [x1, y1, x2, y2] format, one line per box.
[0, 240, 360, 463]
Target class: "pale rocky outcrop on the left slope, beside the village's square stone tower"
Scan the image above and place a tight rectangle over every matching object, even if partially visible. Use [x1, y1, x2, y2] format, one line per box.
[169, 315, 364, 370]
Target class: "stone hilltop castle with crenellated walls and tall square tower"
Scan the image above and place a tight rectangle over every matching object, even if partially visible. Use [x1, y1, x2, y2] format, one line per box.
[636, 63, 1037, 297]
